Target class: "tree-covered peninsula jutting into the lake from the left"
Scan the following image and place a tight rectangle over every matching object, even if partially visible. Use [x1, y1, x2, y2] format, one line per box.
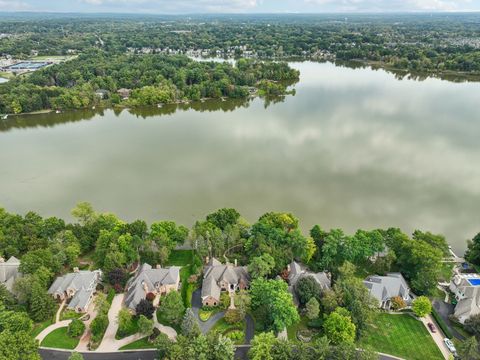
[0, 49, 299, 114]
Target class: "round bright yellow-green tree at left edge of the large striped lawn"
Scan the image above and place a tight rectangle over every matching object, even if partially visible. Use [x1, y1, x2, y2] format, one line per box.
[323, 308, 355, 344]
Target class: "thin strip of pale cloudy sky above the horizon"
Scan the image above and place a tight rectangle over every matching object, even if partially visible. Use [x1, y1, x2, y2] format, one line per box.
[0, 0, 480, 14]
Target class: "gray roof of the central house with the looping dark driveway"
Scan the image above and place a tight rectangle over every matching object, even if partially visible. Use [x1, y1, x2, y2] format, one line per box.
[201, 258, 250, 300]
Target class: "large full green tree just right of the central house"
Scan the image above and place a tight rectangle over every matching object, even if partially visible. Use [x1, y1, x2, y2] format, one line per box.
[250, 278, 300, 332]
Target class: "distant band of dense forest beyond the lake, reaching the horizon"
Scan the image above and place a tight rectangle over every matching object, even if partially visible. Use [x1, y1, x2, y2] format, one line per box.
[0, 14, 480, 73]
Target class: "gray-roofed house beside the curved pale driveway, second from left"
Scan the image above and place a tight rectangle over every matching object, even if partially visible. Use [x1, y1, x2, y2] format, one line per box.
[48, 268, 102, 312]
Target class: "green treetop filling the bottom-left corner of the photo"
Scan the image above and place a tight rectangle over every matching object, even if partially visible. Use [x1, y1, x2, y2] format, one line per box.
[0, 330, 41, 360]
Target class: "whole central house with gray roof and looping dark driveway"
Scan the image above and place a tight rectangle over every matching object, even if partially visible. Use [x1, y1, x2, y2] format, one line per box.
[201, 258, 250, 306]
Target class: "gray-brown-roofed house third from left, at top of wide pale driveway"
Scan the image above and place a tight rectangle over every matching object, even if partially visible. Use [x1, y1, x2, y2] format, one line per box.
[125, 264, 180, 311]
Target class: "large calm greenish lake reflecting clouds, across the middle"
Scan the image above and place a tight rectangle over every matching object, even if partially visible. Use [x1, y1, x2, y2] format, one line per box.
[0, 63, 480, 252]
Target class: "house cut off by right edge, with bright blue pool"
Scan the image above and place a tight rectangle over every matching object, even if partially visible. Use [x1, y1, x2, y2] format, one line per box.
[449, 274, 480, 324]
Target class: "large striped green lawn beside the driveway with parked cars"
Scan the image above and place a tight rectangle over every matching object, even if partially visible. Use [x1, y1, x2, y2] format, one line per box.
[360, 314, 443, 360]
